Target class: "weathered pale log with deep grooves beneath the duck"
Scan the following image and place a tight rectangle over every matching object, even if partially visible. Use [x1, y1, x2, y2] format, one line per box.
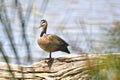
[0, 54, 120, 80]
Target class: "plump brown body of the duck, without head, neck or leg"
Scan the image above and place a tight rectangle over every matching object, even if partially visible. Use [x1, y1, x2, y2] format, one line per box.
[38, 34, 69, 53]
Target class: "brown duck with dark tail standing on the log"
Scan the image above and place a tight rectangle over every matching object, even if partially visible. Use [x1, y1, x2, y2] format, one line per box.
[37, 19, 70, 59]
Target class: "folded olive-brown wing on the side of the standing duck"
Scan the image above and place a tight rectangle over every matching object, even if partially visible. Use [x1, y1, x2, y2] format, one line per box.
[48, 34, 69, 46]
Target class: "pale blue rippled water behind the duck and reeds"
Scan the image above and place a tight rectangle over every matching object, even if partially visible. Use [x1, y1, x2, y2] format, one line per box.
[0, 0, 120, 62]
